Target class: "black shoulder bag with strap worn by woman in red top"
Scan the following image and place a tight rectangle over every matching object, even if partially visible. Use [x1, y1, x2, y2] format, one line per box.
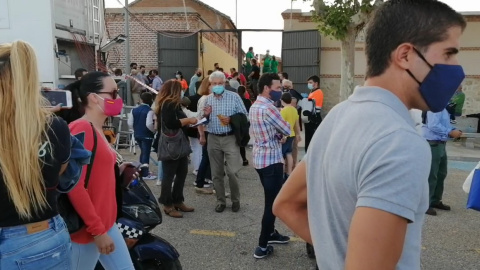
[57, 123, 97, 234]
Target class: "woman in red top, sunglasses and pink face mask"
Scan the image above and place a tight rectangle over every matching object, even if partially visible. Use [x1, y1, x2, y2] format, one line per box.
[68, 72, 134, 270]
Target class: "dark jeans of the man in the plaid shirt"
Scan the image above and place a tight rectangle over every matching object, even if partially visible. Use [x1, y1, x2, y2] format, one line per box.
[257, 163, 285, 248]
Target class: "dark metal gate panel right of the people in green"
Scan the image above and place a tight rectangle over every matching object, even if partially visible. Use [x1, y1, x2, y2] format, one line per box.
[282, 30, 321, 93]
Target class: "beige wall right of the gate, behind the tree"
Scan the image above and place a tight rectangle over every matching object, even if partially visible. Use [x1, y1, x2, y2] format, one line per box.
[282, 10, 480, 114]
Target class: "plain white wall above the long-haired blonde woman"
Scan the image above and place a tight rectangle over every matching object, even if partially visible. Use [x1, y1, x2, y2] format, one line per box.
[0, 0, 56, 84]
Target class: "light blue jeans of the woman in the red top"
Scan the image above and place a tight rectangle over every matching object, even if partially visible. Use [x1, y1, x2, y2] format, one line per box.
[71, 224, 134, 270]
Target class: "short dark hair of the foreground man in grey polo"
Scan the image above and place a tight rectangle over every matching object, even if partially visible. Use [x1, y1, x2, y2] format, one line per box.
[365, 0, 467, 78]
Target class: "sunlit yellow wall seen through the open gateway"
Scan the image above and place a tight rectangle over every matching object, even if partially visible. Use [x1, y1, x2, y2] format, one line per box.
[198, 37, 238, 75]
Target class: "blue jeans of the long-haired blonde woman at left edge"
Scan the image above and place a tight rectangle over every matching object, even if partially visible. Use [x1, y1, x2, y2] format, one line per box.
[0, 215, 72, 270]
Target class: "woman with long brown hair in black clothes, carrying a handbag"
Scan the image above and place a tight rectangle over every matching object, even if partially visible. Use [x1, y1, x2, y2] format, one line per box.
[155, 80, 197, 218]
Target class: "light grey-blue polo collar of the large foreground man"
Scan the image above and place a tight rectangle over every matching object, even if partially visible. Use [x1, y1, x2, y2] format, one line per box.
[348, 86, 415, 127]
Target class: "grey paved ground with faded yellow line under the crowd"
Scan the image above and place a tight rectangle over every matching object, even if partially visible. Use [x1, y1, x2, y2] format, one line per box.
[120, 144, 480, 270]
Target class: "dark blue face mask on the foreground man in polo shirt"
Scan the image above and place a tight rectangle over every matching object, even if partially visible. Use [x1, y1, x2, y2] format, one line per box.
[407, 48, 465, 113]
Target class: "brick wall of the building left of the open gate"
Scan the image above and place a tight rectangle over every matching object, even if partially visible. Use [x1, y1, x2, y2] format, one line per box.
[105, 0, 238, 70]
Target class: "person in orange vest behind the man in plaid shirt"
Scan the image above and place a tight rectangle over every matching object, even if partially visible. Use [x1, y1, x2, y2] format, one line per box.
[305, 75, 323, 153]
